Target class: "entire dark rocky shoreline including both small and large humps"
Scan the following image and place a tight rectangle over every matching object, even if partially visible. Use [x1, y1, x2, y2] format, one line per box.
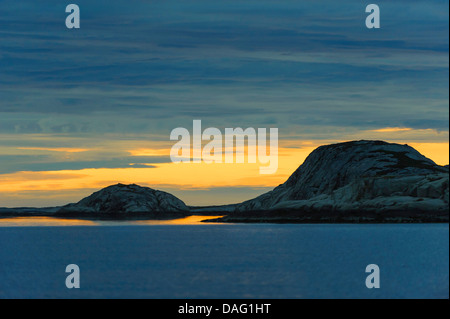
[0, 140, 449, 223]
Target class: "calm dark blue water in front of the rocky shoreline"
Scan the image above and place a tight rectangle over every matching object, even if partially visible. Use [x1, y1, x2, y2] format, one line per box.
[0, 217, 449, 298]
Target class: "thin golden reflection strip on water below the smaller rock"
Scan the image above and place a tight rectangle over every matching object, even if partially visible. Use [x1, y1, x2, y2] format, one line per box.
[0, 215, 223, 227]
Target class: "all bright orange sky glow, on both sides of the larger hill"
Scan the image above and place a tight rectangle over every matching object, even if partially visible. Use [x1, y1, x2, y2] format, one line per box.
[0, 140, 449, 206]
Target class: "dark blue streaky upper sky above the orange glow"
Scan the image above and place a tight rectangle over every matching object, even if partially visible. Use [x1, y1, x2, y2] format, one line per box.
[0, 0, 448, 133]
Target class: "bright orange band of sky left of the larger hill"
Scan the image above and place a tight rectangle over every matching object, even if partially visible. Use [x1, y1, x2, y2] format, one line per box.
[0, 147, 315, 192]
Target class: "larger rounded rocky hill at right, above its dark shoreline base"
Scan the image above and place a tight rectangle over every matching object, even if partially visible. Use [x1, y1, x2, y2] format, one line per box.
[235, 141, 449, 213]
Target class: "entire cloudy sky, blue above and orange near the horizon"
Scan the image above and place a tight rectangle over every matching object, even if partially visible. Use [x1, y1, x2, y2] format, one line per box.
[0, 0, 449, 207]
